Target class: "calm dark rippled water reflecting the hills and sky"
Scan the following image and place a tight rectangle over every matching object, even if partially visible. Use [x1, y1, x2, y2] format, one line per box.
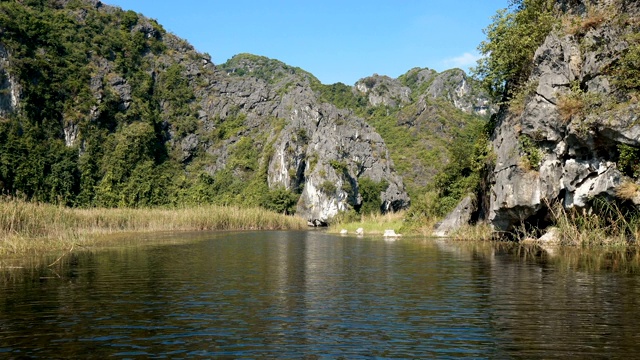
[0, 232, 640, 358]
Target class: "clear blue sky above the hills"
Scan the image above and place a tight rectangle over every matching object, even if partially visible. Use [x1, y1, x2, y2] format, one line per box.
[103, 0, 508, 85]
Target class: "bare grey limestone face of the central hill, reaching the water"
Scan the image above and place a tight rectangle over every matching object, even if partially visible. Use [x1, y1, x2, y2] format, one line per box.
[202, 55, 409, 223]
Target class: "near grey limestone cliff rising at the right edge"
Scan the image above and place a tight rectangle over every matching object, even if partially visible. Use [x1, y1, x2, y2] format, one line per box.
[488, 1, 640, 231]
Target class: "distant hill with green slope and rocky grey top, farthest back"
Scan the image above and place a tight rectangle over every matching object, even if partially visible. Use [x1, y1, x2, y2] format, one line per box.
[351, 68, 497, 197]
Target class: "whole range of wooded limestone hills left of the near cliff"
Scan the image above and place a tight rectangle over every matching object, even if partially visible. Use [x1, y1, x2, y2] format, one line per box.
[0, 0, 490, 221]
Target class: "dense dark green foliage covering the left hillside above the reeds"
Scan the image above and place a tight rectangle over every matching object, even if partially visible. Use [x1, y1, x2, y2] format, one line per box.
[0, 0, 298, 213]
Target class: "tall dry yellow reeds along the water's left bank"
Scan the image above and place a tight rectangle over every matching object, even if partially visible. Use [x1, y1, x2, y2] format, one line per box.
[0, 199, 306, 255]
